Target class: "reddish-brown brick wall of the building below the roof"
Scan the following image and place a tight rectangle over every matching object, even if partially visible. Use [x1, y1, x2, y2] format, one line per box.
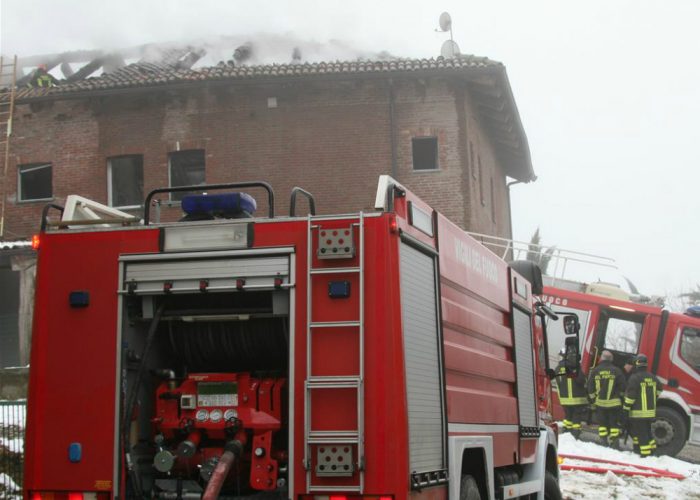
[0, 78, 510, 238]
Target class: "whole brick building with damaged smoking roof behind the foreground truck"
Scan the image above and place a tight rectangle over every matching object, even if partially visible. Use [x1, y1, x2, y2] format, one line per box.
[0, 51, 535, 368]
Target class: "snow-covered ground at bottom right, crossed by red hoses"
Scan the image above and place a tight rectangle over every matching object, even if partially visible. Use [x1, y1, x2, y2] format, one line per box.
[559, 434, 700, 500]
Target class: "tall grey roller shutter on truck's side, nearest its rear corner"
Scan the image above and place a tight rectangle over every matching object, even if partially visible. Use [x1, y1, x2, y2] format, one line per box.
[401, 243, 445, 473]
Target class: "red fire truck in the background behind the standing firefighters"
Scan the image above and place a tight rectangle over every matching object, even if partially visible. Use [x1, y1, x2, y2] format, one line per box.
[543, 277, 700, 455]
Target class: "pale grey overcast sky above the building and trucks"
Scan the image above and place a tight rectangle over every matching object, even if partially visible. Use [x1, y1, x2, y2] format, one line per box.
[0, 0, 700, 294]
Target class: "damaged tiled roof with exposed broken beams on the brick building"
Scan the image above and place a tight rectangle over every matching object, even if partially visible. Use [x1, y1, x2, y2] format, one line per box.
[0, 47, 536, 182]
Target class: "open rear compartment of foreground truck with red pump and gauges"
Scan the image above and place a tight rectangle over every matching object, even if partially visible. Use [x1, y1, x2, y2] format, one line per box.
[119, 247, 290, 498]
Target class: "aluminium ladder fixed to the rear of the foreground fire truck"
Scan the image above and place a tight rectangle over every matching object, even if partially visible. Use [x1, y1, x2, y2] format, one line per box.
[304, 212, 365, 493]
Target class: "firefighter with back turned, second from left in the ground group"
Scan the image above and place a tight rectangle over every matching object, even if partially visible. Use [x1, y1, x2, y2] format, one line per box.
[588, 351, 625, 448]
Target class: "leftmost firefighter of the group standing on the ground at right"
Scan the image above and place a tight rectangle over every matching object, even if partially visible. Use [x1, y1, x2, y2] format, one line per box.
[555, 347, 588, 439]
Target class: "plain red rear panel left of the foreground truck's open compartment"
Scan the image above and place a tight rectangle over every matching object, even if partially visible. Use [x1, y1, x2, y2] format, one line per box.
[25, 230, 158, 491]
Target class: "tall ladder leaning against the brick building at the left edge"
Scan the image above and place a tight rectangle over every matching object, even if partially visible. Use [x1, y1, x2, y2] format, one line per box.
[0, 55, 17, 238]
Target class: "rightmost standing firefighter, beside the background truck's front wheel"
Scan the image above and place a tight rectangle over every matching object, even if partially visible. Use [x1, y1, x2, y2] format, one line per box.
[622, 354, 661, 457]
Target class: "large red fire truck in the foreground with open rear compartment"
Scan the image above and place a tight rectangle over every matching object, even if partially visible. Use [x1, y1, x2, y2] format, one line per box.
[24, 177, 560, 500]
